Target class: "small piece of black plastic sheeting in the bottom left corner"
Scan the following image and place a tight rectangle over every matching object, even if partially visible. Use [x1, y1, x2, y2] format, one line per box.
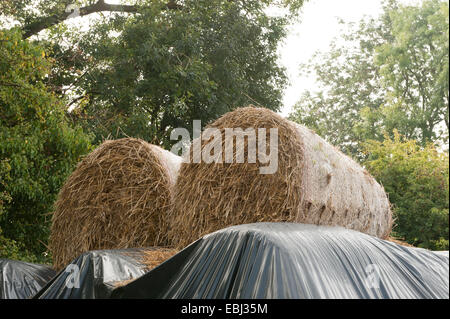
[0, 259, 56, 299]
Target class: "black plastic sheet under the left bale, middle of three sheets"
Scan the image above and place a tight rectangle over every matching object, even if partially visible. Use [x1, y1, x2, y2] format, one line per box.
[34, 248, 151, 299]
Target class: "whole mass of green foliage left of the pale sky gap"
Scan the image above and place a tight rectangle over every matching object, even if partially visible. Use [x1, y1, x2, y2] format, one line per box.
[0, 0, 303, 262]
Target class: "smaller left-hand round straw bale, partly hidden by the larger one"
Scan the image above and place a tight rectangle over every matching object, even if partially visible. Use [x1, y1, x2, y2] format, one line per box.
[49, 138, 181, 269]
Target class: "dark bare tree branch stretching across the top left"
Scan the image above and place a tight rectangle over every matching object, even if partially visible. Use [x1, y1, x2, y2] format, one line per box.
[23, 0, 182, 39]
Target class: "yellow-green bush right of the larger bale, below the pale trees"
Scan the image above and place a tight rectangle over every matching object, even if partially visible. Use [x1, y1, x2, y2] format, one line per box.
[364, 130, 449, 250]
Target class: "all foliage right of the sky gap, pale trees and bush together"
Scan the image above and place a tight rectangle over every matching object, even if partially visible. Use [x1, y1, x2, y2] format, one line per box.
[290, 0, 449, 250]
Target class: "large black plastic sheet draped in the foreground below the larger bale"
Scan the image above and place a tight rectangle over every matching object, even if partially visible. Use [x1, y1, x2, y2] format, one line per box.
[112, 223, 449, 299]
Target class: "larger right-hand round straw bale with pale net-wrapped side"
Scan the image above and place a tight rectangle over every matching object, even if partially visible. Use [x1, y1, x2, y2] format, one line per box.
[169, 106, 392, 247]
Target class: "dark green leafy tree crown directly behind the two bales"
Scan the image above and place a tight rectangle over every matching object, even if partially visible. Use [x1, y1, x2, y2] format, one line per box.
[44, 0, 288, 146]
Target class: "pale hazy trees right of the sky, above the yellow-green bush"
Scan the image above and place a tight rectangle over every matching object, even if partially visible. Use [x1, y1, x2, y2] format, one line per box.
[290, 0, 449, 157]
